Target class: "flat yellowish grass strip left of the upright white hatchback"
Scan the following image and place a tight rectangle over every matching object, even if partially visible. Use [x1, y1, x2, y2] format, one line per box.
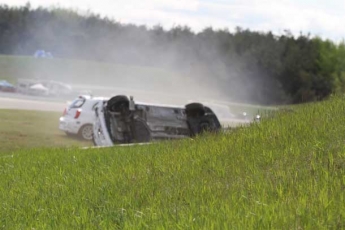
[0, 110, 92, 156]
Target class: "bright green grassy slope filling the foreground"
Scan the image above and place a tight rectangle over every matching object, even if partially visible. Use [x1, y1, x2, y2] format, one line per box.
[0, 97, 345, 229]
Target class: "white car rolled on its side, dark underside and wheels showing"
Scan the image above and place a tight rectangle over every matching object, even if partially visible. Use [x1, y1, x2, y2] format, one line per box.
[93, 95, 221, 146]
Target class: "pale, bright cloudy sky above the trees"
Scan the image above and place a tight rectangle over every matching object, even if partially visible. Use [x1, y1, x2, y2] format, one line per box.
[0, 0, 345, 42]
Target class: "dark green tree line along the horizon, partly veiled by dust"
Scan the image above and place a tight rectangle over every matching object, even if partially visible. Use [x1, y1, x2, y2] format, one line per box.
[0, 4, 345, 104]
